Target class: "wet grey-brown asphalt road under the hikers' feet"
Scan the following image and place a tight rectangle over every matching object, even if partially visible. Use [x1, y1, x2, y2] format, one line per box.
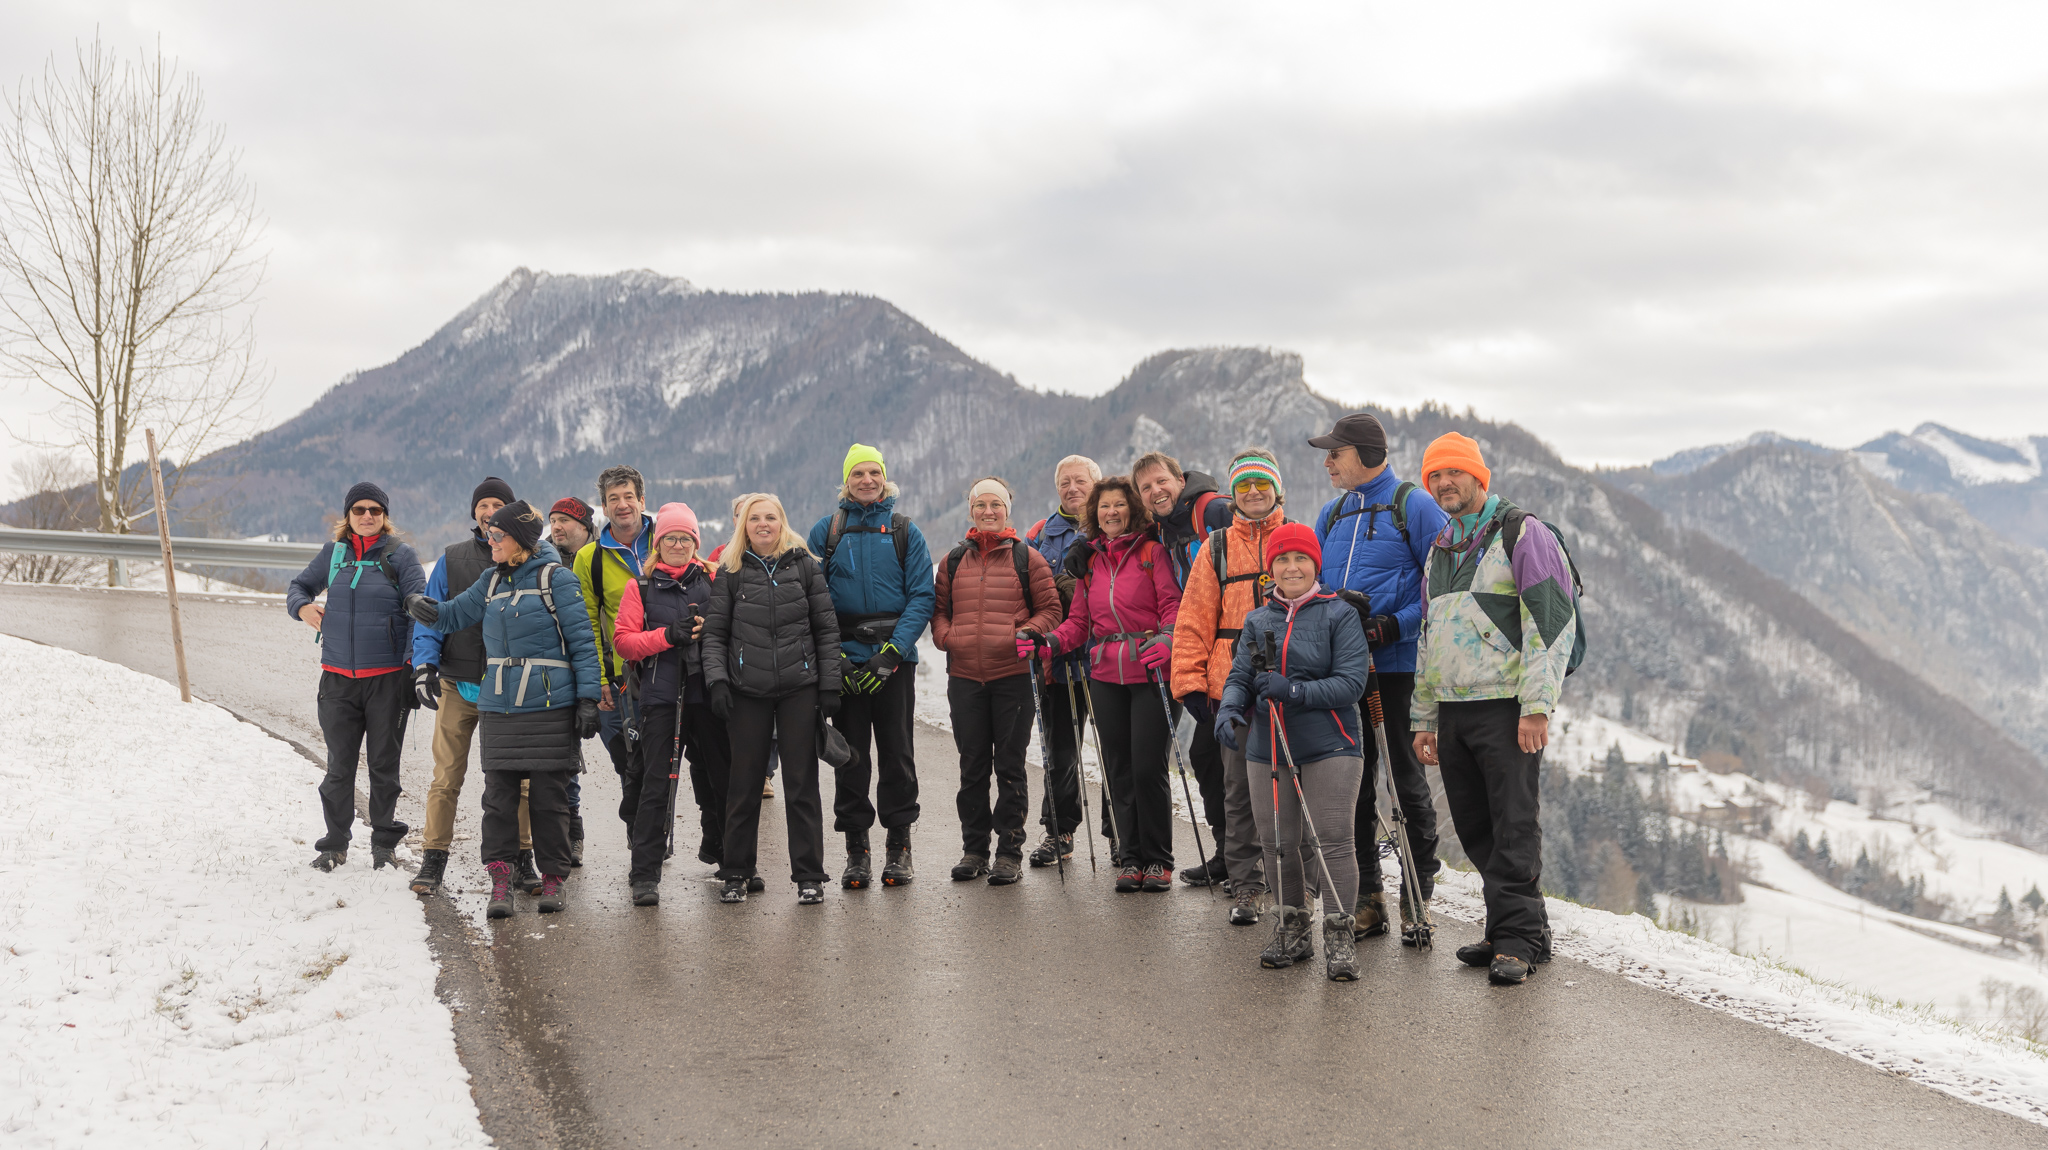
[0, 587, 2048, 1148]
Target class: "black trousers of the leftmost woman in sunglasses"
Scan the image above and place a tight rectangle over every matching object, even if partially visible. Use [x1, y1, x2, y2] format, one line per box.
[313, 671, 409, 851]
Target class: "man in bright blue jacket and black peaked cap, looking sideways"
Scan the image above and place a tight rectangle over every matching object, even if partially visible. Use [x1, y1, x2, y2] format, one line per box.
[1309, 413, 1444, 945]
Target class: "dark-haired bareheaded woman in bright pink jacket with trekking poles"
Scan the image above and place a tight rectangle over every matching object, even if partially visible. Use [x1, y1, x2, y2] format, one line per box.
[1018, 475, 1180, 892]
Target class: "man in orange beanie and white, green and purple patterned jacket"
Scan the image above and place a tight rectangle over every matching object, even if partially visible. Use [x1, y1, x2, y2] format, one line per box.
[1411, 432, 1577, 984]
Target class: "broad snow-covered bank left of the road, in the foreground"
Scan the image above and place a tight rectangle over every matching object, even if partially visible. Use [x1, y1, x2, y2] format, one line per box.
[0, 636, 489, 1146]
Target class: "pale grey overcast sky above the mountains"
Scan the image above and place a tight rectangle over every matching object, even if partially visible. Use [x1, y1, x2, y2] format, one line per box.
[0, 0, 2048, 487]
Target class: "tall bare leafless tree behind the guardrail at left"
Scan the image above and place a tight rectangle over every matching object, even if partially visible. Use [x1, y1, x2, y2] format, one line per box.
[0, 39, 266, 581]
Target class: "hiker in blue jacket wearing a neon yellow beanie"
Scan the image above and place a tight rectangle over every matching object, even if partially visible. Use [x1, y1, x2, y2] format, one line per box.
[805, 444, 938, 888]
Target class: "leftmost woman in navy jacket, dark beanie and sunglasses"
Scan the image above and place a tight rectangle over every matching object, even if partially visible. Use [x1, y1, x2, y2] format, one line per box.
[285, 483, 426, 870]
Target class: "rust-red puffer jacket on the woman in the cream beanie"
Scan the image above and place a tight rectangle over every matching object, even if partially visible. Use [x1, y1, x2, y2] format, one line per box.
[932, 528, 1063, 683]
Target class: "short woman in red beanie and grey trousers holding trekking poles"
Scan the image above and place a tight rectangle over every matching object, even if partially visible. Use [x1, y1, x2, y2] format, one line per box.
[1217, 524, 1370, 982]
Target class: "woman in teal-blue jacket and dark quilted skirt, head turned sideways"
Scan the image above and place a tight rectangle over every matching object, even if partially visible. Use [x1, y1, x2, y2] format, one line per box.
[406, 499, 598, 919]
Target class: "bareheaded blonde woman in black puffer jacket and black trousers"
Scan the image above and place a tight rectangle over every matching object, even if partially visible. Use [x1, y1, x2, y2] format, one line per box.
[705, 495, 840, 904]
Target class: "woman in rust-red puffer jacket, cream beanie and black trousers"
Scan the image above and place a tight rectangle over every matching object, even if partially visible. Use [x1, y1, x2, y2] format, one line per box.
[932, 477, 1061, 886]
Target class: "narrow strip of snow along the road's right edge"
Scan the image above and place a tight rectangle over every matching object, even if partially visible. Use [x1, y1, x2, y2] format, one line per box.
[1433, 870, 2048, 1125]
